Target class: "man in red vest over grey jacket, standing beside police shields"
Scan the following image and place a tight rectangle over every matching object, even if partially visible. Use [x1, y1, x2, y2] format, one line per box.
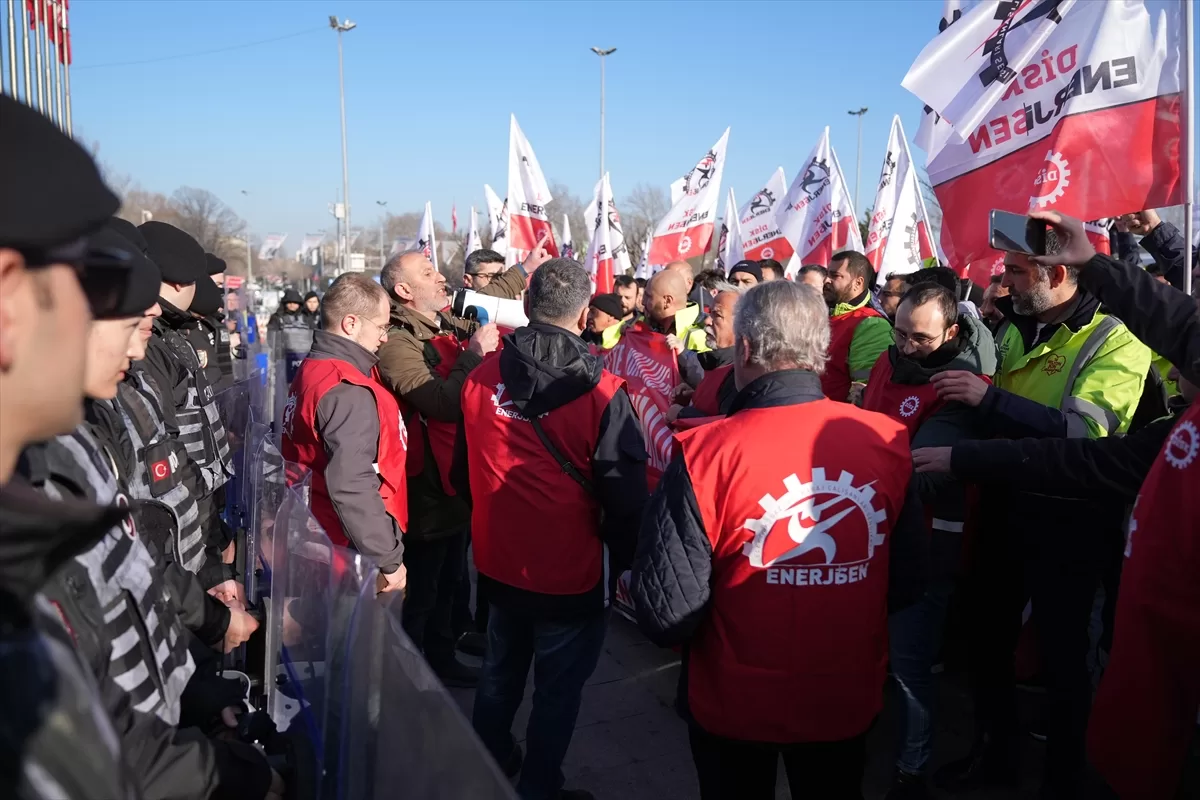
[282, 272, 408, 591]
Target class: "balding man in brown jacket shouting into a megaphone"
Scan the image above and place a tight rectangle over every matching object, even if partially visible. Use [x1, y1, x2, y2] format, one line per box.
[379, 231, 550, 686]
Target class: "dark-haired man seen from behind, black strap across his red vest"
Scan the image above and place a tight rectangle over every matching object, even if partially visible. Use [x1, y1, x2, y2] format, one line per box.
[455, 258, 647, 800]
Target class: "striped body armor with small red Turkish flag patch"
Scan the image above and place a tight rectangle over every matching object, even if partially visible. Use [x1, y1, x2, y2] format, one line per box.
[110, 372, 206, 573]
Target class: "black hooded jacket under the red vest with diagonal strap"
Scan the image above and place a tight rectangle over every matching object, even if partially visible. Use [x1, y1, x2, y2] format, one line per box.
[450, 323, 649, 616]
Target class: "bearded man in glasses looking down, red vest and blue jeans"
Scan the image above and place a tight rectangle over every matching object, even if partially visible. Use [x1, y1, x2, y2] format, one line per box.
[863, 283, 996, 800]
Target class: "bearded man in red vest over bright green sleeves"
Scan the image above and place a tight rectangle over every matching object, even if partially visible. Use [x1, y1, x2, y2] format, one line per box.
[821, 249, 892, 402]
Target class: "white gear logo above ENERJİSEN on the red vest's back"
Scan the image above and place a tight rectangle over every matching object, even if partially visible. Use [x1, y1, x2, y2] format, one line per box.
[742, 467, 887, 567]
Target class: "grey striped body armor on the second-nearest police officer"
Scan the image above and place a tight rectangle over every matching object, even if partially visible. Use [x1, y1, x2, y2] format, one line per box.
[35, 426, 196, 724]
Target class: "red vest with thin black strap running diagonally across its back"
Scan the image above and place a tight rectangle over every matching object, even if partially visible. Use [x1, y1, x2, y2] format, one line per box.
[462, 353, 624, 595]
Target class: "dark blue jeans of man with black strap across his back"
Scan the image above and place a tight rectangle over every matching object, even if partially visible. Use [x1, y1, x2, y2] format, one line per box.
[472, 604, 608, 800]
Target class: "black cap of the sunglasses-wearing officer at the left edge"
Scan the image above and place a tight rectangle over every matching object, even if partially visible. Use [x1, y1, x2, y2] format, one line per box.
[0, 95, 121, 251]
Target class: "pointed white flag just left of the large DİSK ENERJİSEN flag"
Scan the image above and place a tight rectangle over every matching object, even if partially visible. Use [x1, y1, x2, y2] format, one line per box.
[865, 115, 934, 285]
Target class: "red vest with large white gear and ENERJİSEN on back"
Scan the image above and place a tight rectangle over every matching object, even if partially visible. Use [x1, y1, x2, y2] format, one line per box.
[676, 399, 912, 742]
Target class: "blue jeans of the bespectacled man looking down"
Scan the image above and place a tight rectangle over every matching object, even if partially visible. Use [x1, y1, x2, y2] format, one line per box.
[888, 576, 954, 775]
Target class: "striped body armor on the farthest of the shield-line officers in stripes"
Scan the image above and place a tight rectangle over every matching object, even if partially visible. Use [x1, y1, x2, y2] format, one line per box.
[154, 319, 233, 494]
